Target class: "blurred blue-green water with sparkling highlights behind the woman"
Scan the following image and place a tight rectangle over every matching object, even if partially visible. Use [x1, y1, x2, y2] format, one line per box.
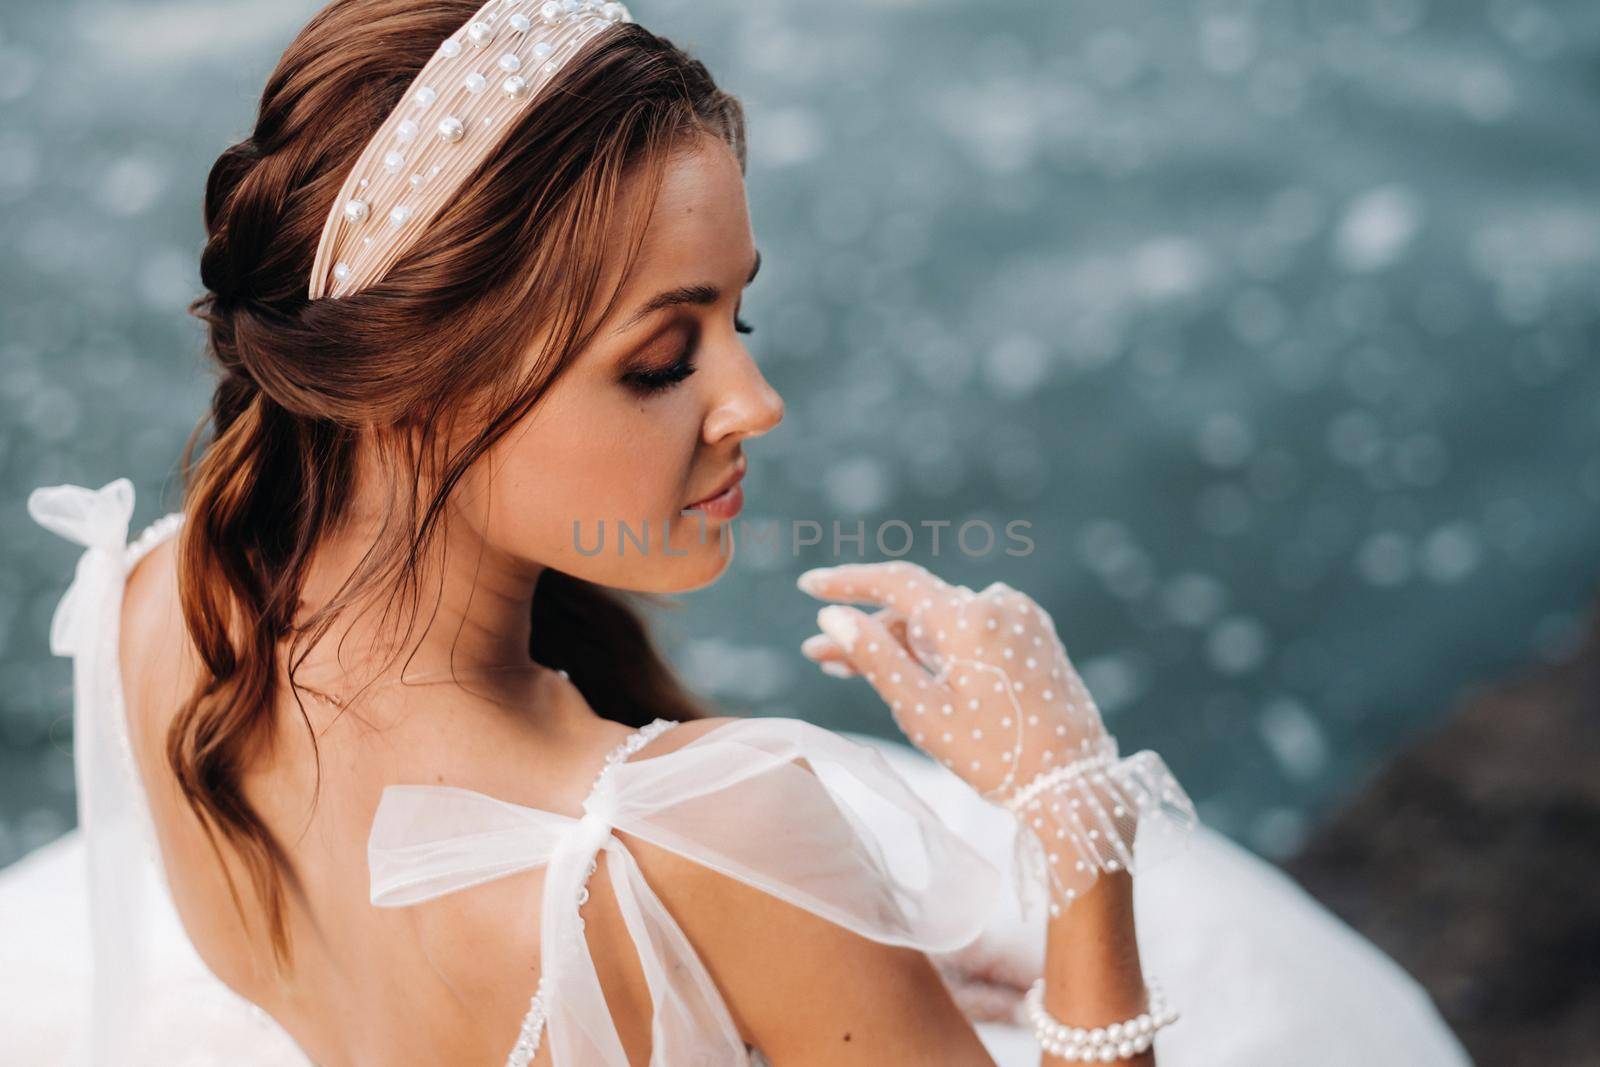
[0, 0, 1600, 864]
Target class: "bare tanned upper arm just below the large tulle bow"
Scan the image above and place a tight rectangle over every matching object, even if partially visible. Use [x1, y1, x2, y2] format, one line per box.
[608, 717, 994, 1067]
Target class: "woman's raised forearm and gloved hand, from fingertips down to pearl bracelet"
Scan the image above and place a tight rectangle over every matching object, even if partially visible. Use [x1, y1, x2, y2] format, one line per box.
[798, 561, 1190, 1067]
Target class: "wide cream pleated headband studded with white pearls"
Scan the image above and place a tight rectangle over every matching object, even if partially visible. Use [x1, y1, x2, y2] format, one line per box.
[309, 0, 632, 299]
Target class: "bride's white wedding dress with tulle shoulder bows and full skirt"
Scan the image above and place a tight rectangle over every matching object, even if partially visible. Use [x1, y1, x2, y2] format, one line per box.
[0, 478, 1469, 1067]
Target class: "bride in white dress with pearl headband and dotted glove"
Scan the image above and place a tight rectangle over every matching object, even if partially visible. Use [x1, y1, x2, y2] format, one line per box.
[0, 0, 1466, 1067]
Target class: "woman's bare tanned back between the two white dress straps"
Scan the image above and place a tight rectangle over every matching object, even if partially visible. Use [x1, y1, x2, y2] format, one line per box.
[120, 542, 736, 1065]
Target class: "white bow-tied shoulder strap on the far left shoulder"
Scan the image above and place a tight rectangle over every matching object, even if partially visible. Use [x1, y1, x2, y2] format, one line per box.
[27, 478, 182, 1065]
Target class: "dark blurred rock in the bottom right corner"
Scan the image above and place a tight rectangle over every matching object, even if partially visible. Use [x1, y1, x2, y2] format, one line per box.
[1286, 598, 1600, 1065]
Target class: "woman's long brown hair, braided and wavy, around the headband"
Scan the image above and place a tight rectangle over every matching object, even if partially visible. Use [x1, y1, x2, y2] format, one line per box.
[166, 0, 746, 966]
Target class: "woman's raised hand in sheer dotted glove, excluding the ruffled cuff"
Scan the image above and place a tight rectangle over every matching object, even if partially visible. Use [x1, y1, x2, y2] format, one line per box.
[798, 561, 1107, 798]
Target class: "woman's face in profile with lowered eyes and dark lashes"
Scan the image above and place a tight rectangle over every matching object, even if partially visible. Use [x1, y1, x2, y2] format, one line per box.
[456, 136, 784, 592]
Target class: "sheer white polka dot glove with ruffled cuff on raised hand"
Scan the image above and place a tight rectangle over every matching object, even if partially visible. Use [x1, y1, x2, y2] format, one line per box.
[798, 561, 1195, 915]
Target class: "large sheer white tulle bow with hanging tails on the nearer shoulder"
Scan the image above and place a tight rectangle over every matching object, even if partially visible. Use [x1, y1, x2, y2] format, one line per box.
[368, 718, 1002, 1067]
